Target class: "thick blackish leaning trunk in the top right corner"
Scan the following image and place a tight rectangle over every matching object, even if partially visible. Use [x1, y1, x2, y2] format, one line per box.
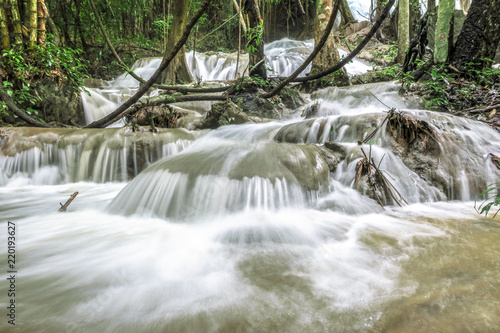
[451, 0, 500, 69]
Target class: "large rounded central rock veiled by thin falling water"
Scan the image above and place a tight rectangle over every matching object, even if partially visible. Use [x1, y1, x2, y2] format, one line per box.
[110, 139, 337, 219]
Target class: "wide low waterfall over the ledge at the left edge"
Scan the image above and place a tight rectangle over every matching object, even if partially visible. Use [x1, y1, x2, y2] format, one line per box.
[0, 128, 195, 186]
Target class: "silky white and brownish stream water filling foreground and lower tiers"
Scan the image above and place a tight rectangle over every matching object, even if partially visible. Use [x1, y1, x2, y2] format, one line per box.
[0, 39, 500, 333]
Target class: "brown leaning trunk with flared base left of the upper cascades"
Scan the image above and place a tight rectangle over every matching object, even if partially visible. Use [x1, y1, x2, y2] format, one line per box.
[161, 0, 193, 84]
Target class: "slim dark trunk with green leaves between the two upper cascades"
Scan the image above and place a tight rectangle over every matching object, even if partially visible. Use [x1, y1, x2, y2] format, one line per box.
[244, 0, 267, 79]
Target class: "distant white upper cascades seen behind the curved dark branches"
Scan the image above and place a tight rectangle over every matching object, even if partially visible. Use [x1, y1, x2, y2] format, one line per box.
[81, 38, 372, 126]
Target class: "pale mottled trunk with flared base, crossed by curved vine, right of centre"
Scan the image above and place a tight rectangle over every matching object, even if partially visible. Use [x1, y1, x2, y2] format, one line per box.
[311, 0, 349, 83]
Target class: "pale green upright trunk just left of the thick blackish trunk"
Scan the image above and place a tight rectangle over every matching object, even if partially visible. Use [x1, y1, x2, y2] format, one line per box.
[434, 0, 455, 63]
